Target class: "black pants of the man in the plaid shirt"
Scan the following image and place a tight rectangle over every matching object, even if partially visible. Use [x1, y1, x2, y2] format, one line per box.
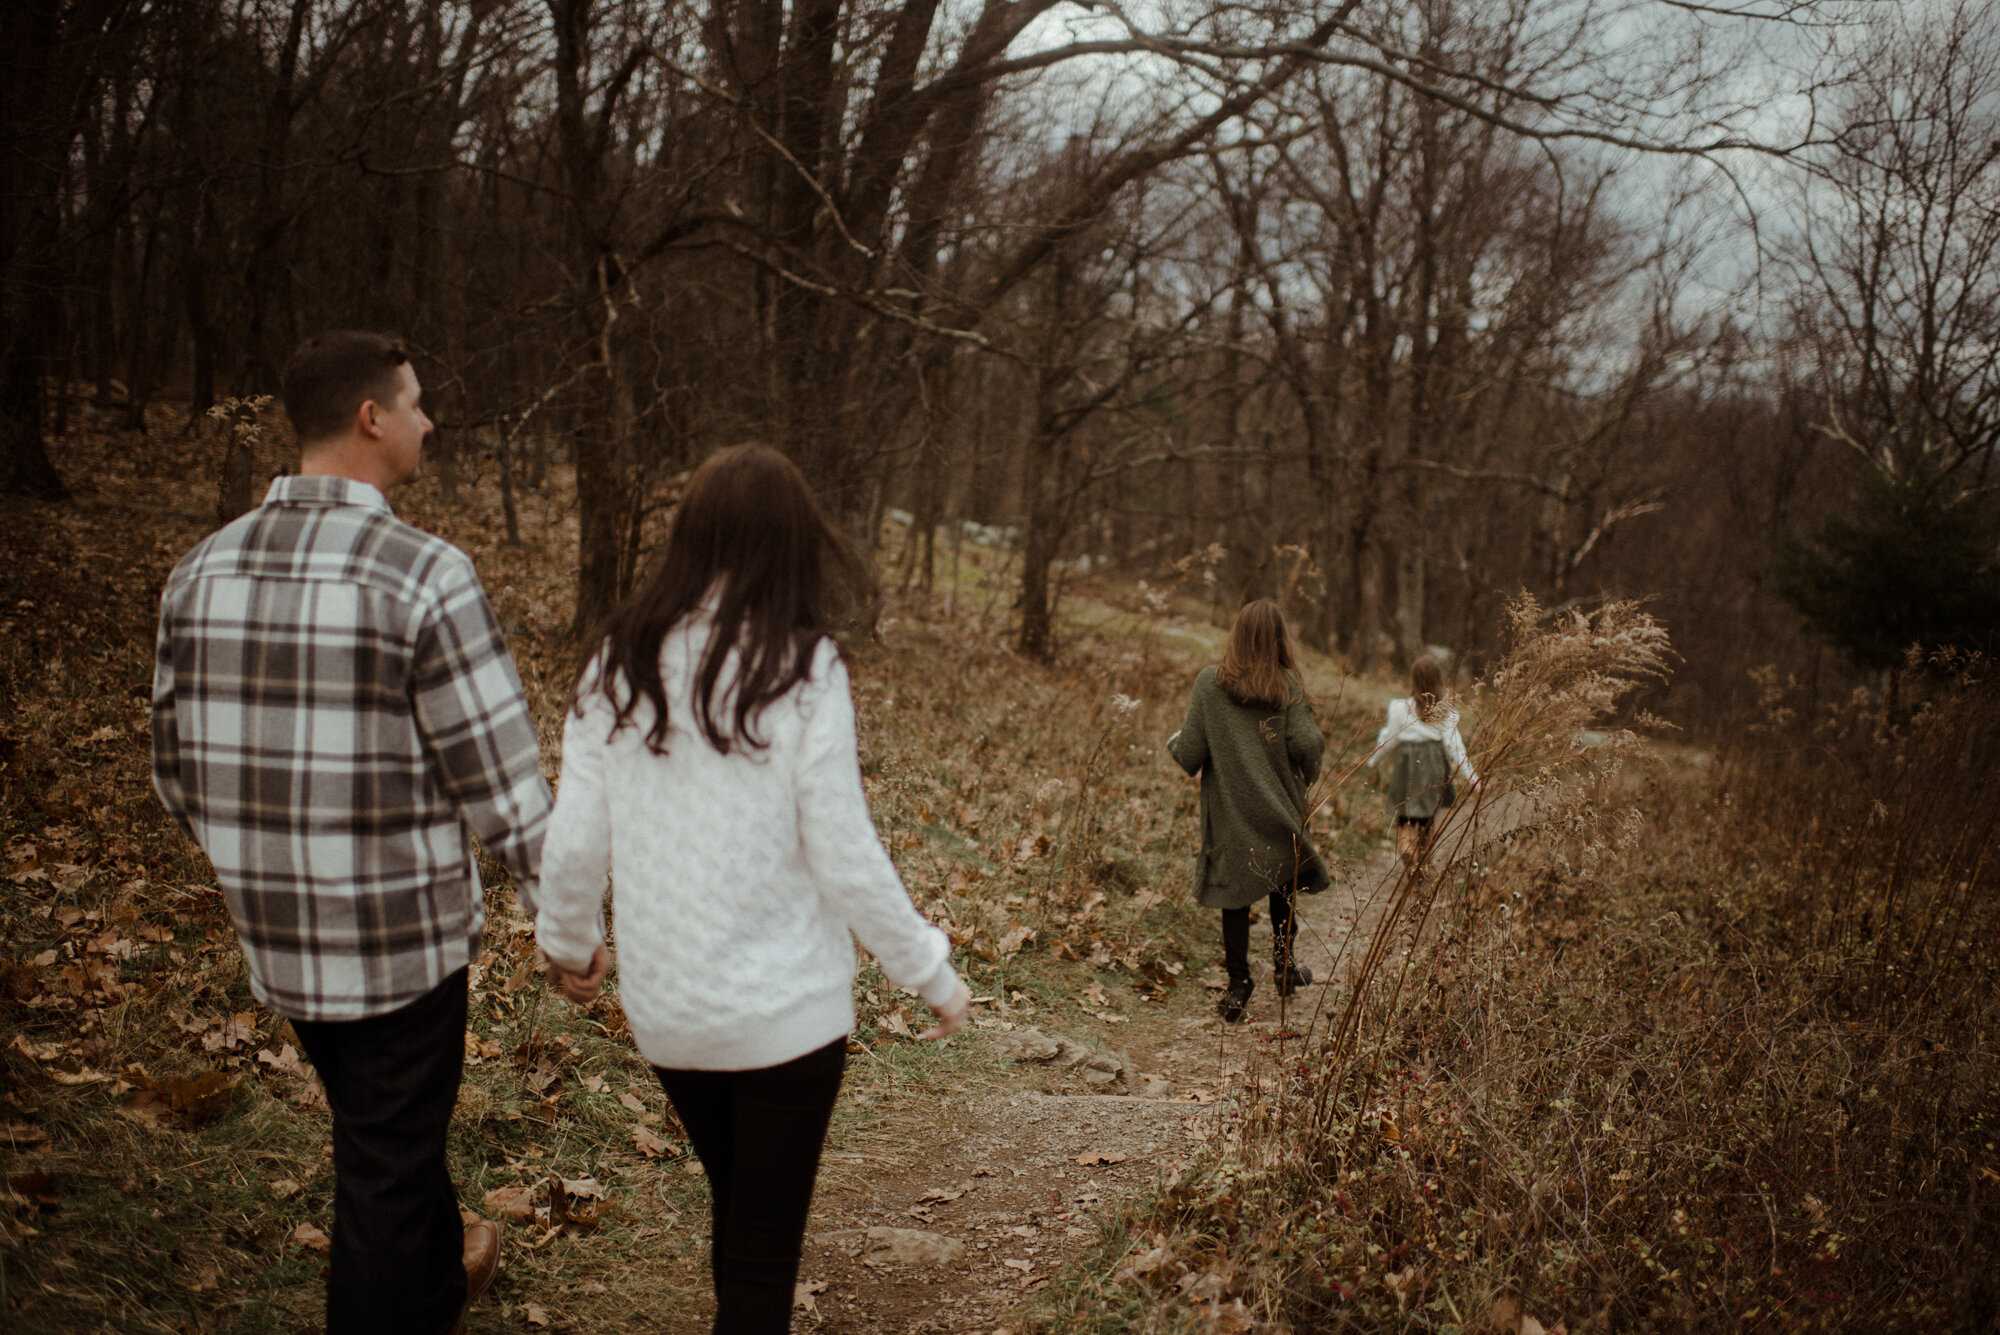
[292, 969, 466, 1335]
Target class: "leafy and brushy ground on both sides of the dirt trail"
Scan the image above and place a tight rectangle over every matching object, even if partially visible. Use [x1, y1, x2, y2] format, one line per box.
[11, 413, 2000, 1335]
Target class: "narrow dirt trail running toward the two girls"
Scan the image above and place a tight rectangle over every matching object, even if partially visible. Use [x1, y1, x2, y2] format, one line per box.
[796, 799, 1530, 1335]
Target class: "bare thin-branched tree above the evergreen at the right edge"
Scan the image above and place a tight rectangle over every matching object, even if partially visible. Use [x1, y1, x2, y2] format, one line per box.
[1784, 0, 2000, 490]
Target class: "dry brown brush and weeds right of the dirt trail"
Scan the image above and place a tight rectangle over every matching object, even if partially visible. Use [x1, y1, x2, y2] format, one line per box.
[1042, 639, 2000, 1335]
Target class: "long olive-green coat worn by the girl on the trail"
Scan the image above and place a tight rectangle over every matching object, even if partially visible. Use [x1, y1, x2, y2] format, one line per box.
[1166, 668, 1326, 909]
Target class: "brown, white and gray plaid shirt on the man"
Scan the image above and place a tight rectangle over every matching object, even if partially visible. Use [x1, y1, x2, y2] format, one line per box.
[152, 478, 550, 1019]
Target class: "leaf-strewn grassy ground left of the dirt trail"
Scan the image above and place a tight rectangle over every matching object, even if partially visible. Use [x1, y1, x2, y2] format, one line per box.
[0, 414, 1370, 1331]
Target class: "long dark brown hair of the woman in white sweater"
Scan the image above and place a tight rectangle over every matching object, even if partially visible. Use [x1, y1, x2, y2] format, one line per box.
[572, 444, 874, 755]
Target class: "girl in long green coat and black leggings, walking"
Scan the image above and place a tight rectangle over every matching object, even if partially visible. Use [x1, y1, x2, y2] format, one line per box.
[1166, 598, 1326, 1023]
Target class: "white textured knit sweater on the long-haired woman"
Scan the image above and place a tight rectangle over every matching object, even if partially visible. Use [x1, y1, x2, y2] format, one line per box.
[536, 616, 958, 1071]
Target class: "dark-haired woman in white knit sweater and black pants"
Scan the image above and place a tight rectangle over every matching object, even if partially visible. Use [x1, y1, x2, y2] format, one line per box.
[536, 446, 970, 1331]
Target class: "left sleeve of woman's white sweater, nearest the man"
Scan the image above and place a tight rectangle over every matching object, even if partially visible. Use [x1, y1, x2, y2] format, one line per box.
[534, 683, 612, 971]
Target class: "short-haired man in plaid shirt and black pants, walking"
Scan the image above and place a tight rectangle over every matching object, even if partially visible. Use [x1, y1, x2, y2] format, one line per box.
[152, 332, 584, 1335]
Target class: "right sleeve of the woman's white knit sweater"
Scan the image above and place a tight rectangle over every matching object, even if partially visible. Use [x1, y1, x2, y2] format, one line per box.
[796, 640, 958, 1005]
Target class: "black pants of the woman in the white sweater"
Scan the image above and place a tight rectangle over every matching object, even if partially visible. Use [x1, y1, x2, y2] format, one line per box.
[654, 1037, 848, 1335]
